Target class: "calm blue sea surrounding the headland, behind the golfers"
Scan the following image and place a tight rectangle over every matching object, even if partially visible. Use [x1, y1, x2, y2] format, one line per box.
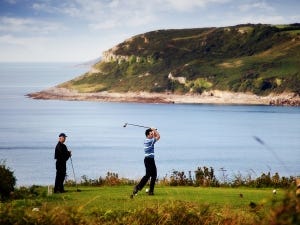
[0, 63, 300, 186]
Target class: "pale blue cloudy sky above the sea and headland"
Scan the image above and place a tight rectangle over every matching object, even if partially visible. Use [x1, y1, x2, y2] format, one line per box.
[0, 0, 300, 62]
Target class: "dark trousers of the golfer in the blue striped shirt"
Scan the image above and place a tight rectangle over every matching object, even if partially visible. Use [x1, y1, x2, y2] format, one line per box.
[136, 157, 157, 192]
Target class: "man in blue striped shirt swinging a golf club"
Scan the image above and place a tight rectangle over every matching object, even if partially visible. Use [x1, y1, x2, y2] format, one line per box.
[133, 128, 160, 195]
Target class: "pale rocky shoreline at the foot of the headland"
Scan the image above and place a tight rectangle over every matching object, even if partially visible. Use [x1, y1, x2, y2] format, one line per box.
[27, 86, 300, 106]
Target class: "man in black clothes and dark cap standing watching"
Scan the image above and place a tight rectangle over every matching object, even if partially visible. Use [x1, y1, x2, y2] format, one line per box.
[54, 133, 71, 193]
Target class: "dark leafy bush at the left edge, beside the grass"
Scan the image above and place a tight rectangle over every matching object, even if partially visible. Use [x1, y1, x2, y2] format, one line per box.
[0, 161, 16, 200]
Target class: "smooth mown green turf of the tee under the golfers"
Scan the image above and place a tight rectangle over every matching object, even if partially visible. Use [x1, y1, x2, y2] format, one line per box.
[44, 186, 284, 213]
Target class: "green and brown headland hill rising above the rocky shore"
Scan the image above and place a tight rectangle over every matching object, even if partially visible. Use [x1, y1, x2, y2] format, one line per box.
[60, 24, 300, 95]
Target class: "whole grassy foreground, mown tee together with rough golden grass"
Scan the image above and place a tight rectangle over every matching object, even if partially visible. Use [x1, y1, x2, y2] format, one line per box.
[0, 185, 300, 225]
